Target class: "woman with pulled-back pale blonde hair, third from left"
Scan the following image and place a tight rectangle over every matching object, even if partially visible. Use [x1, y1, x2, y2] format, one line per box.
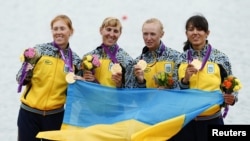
[131, 18, 180, 88]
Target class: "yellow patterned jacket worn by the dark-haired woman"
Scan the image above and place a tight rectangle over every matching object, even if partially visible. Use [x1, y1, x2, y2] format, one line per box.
[175, 45, 232, 116]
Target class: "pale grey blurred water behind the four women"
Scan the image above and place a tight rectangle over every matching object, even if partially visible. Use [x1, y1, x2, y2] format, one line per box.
[0, 0, 250, 141]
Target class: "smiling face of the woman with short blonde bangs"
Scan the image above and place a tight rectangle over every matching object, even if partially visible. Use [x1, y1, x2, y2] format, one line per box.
[100, 26, 121, 46]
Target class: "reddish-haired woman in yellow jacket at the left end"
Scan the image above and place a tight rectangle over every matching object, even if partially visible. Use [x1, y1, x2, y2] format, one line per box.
[17, 15, 81, 141]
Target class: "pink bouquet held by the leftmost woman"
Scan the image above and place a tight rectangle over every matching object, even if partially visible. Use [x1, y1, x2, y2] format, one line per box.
[20, 48, 41, 65]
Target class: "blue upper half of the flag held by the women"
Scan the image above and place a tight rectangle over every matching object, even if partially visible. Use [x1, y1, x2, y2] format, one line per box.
[63, 81, 223, 127]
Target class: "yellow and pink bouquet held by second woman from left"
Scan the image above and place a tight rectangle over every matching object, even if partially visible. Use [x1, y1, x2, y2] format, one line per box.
[82, 55, 101, 71]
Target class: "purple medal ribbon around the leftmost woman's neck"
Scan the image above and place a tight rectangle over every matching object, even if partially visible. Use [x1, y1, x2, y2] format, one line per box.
[53, 42, 73, 72]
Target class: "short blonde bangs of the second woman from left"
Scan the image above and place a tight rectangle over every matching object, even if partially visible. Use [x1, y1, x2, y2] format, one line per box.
[100, 17, 122, 32]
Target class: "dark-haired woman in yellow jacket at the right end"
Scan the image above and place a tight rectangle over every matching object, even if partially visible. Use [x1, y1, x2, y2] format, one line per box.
[171, 15, 237, 141]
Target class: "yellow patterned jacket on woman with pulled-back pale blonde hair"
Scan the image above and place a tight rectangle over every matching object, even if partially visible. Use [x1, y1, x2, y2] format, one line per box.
[134, 42, 180, 88]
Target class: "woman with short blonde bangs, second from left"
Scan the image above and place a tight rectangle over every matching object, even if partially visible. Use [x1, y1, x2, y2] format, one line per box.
[78, 17, 133, 88]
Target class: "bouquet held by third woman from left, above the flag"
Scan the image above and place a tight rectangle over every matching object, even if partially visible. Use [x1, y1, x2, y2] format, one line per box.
[154, 72, 174, 88]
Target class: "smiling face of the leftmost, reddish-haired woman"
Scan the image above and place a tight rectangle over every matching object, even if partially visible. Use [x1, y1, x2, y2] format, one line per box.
[52, 20, 72, 48]
